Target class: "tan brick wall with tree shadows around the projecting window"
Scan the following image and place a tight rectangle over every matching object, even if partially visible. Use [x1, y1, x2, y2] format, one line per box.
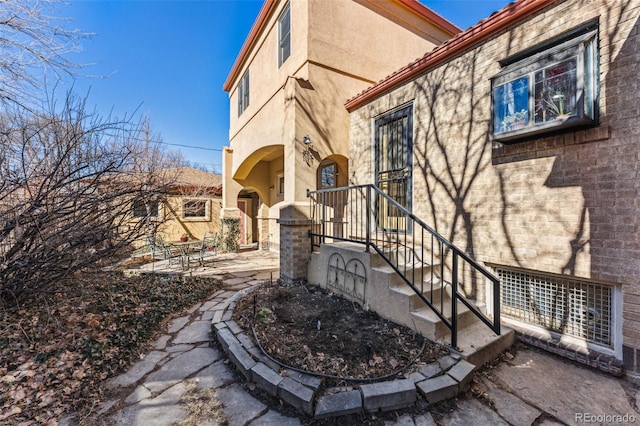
[350, 0, 640, 356]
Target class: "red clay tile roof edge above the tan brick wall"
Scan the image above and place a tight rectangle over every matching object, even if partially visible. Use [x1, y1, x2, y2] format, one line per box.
[345, 0, 556, 112]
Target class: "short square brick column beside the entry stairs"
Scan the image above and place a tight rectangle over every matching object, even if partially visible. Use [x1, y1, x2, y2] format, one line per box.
[278, 203, 311, 283]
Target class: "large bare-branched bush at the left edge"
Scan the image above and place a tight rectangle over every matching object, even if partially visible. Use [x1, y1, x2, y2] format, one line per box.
[0, 96, 180, 305]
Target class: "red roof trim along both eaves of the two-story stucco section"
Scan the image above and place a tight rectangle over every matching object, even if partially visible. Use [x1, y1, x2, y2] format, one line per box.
[222, 0, 461, 92]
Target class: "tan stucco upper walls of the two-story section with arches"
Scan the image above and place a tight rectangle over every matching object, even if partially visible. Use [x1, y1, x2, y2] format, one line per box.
[225, 0, 458, 205]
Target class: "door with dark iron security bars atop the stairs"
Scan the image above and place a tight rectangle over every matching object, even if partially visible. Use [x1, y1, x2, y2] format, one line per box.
[375, 106, 413, 230]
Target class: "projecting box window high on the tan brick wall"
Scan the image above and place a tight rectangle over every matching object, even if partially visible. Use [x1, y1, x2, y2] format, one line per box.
[491, 24, 598, 142]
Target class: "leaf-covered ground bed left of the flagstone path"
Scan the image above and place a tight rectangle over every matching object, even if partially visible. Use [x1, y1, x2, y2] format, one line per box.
[0, 272, 221, 426]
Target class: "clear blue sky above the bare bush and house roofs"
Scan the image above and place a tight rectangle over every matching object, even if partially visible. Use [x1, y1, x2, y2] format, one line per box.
[59, 0, 509, 172]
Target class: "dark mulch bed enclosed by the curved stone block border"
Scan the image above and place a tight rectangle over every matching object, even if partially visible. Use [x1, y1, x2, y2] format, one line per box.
[233, 283, 448, 385]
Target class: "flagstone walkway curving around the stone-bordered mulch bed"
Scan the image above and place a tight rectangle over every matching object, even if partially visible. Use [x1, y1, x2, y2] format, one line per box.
[82, 251, 640, 426]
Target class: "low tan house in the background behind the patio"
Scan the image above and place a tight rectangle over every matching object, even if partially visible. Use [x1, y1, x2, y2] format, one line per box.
[131, 167, 222, 244]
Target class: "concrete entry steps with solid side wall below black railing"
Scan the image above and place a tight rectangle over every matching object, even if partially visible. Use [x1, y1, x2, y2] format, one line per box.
[308, 242, 515, 366]
